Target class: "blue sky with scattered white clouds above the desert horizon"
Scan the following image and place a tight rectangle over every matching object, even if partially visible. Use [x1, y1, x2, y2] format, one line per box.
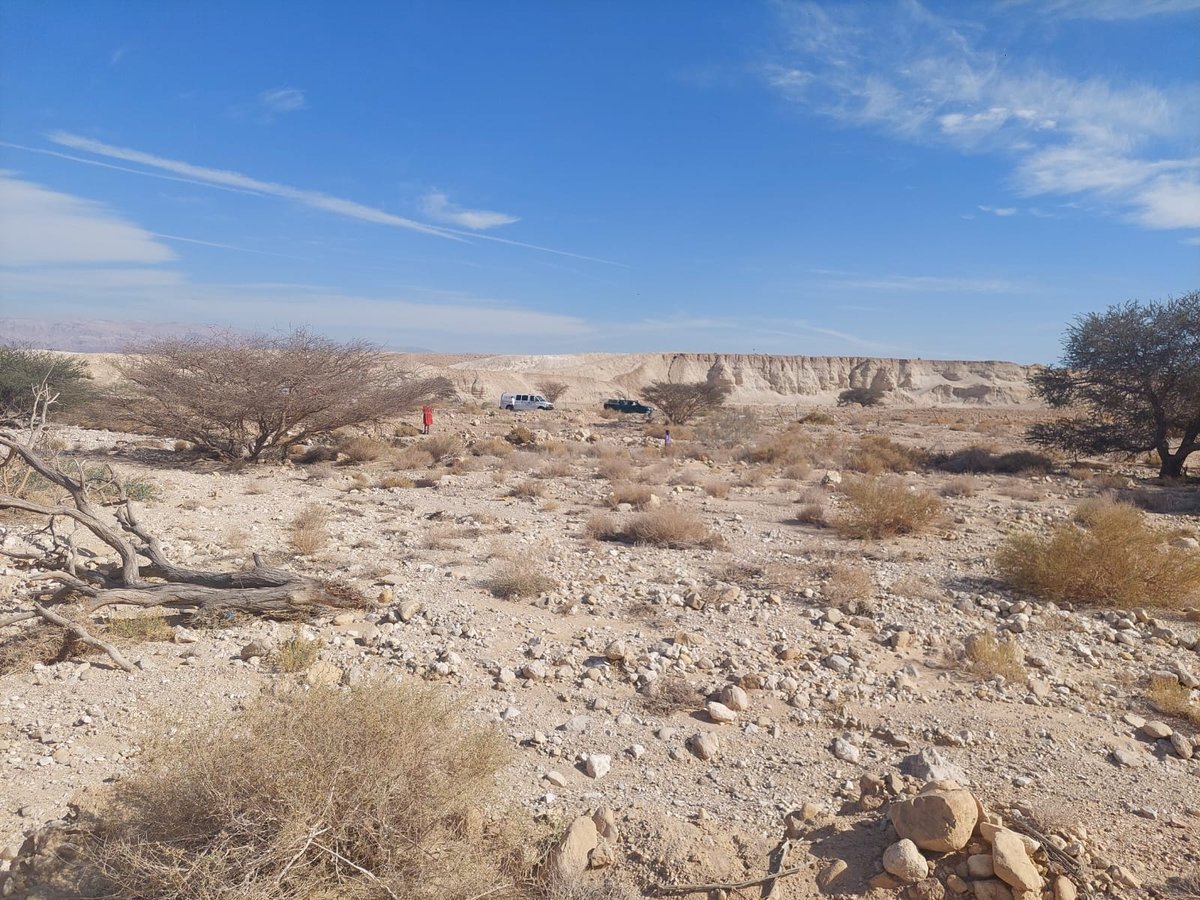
[0, 0, 1200, 361]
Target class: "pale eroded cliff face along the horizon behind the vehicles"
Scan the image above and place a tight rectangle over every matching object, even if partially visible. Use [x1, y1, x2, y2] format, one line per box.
[434, 353, 1034, 406]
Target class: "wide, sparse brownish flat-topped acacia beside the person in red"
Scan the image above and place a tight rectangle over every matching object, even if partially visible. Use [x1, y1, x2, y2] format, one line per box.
[118, 329, 452, 461]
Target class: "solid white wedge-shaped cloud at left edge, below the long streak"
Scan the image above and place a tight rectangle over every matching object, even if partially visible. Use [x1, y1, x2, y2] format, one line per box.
[0, 170, 175, 266]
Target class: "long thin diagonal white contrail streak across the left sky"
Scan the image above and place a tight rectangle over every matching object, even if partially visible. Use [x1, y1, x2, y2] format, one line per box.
[32, 131, 625, 268]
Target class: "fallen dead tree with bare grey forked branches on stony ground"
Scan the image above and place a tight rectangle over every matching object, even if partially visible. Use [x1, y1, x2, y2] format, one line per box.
[0, 432, 362, 671]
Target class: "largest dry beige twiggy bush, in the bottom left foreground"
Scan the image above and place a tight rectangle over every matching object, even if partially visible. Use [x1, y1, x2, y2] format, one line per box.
[75, 683, 528, 900]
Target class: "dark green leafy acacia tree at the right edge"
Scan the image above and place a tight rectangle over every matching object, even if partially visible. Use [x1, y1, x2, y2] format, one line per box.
[1028, 290, 1200, 478]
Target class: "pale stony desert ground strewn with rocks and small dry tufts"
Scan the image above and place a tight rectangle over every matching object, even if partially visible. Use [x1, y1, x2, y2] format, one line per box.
[0, 408, 1200, 900]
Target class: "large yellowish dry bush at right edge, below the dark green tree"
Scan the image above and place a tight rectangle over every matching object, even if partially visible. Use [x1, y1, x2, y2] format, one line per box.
[996, 498, 1200, 607]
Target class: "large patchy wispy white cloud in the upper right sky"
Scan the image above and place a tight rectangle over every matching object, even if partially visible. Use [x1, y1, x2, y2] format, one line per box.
[766, 0, 1200, 228]
